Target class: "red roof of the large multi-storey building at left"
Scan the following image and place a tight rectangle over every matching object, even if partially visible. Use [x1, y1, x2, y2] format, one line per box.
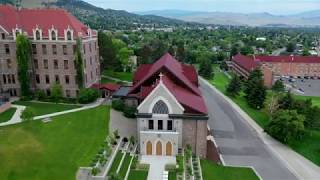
[0, 5, 95, 37]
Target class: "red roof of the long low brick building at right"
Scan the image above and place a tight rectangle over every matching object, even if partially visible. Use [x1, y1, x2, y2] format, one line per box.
[232, 54, 320, 71]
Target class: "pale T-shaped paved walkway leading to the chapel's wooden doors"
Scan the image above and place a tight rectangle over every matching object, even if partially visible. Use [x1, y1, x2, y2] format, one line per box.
[141, 156, 176, 180]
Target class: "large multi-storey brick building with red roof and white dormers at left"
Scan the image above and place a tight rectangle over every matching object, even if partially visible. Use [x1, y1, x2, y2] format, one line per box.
[0, 6, 100, 97]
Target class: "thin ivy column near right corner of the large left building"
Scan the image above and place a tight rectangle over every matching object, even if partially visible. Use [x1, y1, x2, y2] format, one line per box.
[75, 38, 84, 88]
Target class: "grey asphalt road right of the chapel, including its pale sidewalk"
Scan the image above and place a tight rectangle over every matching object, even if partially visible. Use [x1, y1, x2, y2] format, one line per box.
[200, 79, 320, 180]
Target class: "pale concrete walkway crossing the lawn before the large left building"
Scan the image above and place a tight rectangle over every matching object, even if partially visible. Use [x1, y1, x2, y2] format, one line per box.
[0, 98, 104, 126]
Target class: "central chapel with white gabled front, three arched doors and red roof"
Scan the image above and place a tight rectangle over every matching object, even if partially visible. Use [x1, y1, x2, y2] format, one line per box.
[120, 54, 208, 157]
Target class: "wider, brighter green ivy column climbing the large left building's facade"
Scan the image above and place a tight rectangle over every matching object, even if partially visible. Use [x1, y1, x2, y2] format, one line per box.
[16, 34, 31, 97]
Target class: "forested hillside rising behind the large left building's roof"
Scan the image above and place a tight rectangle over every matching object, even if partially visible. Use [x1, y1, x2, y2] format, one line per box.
[0, 0, 195, 30]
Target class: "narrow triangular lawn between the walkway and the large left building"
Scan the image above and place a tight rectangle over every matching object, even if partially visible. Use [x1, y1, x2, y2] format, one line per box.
[13, 101, 81, 116]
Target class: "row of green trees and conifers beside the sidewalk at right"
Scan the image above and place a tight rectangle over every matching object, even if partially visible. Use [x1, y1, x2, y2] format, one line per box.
[226, 69, 320, 143]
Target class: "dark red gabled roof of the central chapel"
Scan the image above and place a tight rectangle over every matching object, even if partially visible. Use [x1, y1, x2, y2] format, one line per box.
[129, 54, 207, 114]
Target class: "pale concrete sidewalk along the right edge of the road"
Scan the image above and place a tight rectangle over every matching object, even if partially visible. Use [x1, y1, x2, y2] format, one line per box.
[200, 77, 320, 180]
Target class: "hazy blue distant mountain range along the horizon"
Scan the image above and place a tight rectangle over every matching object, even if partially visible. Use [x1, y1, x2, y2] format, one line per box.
[135, 10, 320, 26]
